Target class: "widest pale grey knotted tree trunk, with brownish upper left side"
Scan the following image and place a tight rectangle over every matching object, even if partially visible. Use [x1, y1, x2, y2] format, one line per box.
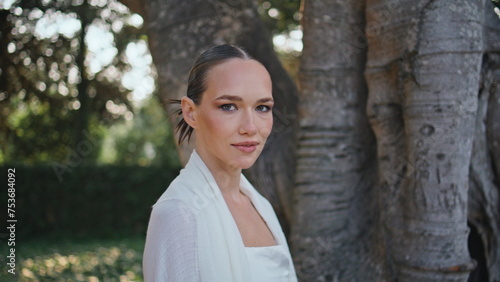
[366, 0, 483, 281]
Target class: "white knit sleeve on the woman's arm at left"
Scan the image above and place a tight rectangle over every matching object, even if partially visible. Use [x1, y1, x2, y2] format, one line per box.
[143, 199, 201, 282]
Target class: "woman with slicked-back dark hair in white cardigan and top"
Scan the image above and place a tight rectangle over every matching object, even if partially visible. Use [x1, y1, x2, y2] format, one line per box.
[143, 44, 297, 282]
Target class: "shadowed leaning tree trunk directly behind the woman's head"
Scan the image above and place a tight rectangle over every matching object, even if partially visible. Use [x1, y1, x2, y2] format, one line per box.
[144, 0, 297, 230]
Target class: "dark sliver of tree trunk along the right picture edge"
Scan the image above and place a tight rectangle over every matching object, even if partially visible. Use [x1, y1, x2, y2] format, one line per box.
[468, 1, 500, 281]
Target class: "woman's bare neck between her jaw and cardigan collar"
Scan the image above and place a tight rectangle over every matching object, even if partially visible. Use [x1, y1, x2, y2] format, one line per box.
[196, 148, 242, 202]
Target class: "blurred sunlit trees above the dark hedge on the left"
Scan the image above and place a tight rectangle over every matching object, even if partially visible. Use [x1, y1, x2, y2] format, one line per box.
[0, 0, 176, 165]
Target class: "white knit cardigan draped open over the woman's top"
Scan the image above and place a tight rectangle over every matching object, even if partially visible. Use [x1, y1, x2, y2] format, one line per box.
[143, 151, 297, 282]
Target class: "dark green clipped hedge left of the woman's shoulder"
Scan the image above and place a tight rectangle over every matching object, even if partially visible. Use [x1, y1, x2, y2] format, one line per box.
[0, 166, 179, 240]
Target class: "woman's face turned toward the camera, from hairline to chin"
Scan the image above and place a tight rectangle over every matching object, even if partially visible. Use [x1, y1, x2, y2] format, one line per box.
[187, 59, 274, 169]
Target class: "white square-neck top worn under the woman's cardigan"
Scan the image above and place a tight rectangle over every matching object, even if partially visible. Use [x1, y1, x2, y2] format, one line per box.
[245, 245, 290, 282]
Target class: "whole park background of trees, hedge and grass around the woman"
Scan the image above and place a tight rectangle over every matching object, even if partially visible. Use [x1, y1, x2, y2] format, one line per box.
[0, 0, 500, 281]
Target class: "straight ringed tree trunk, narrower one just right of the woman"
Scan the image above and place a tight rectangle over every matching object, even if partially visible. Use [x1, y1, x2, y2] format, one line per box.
[291, 1, 377, 281]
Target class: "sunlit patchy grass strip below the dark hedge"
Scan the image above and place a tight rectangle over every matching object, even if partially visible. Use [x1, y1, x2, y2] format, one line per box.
[0, 237, 144, 282]
